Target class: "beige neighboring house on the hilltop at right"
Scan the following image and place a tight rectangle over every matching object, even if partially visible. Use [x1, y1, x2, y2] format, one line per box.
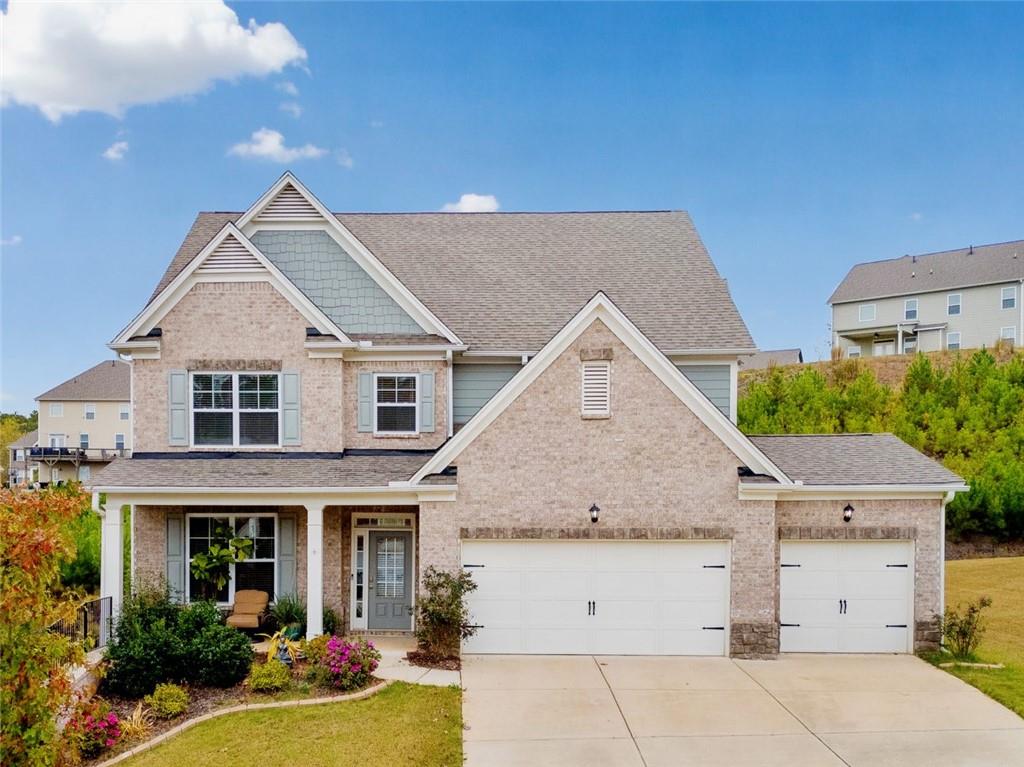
[828, 240, 1024, 356]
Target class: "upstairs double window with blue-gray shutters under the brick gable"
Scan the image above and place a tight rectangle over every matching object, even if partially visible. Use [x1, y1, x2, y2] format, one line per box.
[193, 373, 281, 446]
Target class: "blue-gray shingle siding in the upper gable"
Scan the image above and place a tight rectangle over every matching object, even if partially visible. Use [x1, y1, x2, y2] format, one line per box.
[250, 230, 425, 335]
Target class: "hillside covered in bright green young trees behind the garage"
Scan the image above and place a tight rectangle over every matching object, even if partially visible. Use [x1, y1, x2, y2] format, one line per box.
[737, 349, 1024, 541]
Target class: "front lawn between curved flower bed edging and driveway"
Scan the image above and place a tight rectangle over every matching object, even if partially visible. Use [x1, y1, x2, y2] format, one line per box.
[124, 682, 462, 767]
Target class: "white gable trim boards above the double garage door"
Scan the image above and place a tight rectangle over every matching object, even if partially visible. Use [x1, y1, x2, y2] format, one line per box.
[410, 292, 792, 485]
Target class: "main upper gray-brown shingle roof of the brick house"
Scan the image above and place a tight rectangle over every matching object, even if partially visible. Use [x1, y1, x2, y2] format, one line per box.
[154, 211, 754, 352]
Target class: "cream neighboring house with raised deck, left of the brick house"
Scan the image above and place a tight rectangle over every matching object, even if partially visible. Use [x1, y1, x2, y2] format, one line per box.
[29, 359, 132, 486]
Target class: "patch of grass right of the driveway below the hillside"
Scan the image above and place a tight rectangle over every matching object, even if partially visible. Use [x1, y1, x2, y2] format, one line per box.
[927, 557, 1024, 717]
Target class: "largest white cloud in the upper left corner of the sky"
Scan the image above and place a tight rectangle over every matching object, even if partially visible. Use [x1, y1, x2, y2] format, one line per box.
[0, 0, 306, 122]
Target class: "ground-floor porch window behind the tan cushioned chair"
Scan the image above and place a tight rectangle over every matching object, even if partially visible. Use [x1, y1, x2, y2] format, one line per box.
[187, 514, 278, 602]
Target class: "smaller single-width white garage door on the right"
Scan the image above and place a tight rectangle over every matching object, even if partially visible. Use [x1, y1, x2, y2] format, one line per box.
[779, 541, 913, 652]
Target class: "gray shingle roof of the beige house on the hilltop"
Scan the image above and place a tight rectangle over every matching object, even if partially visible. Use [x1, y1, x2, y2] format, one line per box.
[828, 240, 1024, 303]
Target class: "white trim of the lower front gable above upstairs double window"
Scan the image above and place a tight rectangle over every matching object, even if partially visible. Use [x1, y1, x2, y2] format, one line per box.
[111, 222, 354, 347]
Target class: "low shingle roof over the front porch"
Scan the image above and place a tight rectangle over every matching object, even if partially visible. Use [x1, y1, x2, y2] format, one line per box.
[90, 454, 436, 487]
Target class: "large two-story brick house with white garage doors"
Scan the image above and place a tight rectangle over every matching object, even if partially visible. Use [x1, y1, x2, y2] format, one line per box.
[92, 174, 965, 656]
